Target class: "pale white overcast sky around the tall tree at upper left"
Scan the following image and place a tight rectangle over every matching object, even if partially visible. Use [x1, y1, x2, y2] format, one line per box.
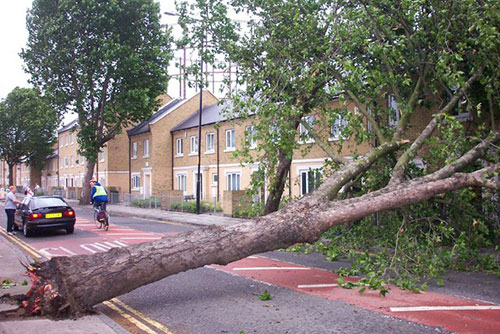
[0, 0, 225, 109]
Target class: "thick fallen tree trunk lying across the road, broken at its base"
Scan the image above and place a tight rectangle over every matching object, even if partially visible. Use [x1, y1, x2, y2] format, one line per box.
[24, 164, 500, 316]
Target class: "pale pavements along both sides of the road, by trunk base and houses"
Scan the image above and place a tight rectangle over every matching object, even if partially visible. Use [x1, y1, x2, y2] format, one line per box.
[0, 200, 245, 334]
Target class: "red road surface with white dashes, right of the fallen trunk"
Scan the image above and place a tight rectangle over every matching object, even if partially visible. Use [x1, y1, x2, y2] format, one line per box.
[212, 256, 500, 334]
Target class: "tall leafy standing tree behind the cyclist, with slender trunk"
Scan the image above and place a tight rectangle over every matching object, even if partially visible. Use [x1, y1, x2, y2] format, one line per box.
[21, 0, 171, 202]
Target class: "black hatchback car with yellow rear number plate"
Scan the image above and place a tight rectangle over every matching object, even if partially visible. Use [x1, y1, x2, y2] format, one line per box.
[15, 196, 76, 237]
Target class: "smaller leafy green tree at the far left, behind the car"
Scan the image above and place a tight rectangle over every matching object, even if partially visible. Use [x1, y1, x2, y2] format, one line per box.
[0, 87, 59, 185]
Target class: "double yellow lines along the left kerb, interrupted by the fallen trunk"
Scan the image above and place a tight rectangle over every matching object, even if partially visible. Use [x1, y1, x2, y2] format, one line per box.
[0, 227, 173, 334]
